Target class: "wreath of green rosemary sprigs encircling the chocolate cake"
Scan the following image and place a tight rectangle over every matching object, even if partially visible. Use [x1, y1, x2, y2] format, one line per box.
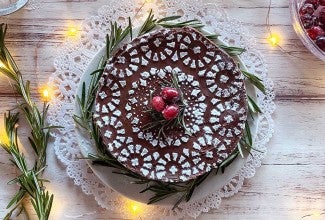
[74, 10, 263, 208]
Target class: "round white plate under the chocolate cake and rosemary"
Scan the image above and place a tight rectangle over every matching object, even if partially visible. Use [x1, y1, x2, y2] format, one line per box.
[75, 28, 258, 205]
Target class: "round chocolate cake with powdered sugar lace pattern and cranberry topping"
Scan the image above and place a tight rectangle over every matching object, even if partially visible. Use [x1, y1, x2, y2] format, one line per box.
[94, 27, 247, 182]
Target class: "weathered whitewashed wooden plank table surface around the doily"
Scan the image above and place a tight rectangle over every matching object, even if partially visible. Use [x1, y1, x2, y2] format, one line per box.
[0, 0, 325, 219]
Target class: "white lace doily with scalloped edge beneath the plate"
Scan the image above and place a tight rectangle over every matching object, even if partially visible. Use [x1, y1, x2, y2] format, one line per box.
[49, 0, 275, 219]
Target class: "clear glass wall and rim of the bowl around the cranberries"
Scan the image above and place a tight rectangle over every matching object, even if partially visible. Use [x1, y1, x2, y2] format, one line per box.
[289, 0, 325, 62]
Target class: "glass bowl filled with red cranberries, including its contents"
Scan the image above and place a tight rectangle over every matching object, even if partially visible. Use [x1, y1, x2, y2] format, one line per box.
[290, 0, 325, 61]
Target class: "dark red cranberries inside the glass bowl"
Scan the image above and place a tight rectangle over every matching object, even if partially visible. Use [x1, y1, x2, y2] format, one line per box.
[299, 0, 325, 51]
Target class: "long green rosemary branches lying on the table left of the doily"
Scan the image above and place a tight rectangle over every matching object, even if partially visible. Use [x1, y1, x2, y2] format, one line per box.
[0, 24, 55, 220]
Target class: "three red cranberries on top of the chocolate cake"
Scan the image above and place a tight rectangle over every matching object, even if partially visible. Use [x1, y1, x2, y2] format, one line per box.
[151, 87, 179, 120]
